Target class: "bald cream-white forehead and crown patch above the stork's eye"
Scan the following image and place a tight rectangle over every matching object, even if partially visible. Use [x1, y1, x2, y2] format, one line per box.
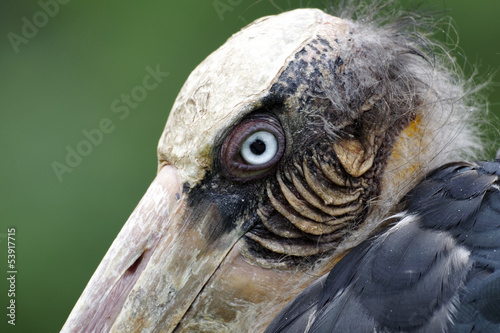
[158, 9, 349, 184]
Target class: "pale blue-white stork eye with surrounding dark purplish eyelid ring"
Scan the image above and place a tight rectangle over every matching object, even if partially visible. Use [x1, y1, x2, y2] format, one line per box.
[220, 117, 285, 181]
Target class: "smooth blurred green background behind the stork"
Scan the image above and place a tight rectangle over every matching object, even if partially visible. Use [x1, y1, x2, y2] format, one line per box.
[0, 0, 500, 332]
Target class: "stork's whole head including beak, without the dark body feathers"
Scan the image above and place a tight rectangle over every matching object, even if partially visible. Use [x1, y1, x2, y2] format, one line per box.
[63, 9, 475, 332]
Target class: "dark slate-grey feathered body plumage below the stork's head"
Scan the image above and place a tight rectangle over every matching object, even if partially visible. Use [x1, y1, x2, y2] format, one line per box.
[266, 160, 500, 332]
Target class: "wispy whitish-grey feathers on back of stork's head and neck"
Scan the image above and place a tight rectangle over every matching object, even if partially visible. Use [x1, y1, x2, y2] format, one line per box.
[326, 1, 487, 248]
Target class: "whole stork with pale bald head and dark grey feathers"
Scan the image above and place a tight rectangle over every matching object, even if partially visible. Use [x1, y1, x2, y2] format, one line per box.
[62, 3, 500, 332]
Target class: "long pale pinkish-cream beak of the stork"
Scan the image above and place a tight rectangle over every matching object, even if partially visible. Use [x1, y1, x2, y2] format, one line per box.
[62, 166, 308, 332]
